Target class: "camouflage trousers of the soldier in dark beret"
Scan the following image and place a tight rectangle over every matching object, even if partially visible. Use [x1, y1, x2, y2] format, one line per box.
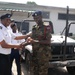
[30, 47, 51, 75]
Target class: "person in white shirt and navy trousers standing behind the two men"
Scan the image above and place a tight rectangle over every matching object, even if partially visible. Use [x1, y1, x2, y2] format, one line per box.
[10, 23, 25, 75]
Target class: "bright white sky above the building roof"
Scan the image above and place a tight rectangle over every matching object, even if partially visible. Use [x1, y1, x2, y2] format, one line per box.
[0, 0, 75, 8]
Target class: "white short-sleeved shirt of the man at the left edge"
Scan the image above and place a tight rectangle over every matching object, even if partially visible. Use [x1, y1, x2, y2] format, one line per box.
[0, 23, 16, 55]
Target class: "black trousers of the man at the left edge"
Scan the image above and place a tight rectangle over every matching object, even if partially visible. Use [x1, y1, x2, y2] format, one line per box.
[0, 54, 11, 75]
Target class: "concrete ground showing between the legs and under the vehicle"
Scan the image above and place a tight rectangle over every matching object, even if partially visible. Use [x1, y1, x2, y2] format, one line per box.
[12, 60, 69, 75]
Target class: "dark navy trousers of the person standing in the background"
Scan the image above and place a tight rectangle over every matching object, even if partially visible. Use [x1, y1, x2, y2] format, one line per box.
[10, 48, 21, 75]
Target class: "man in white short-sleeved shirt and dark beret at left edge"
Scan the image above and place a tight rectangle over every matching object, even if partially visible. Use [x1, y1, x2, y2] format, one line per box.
[0, 14, 28, 75]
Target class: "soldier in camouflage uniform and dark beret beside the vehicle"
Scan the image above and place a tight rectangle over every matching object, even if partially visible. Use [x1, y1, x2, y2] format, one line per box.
[28, 11, 51, 75]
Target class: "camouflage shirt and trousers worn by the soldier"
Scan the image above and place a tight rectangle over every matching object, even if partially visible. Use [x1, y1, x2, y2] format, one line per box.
[30, 22, 51, 75]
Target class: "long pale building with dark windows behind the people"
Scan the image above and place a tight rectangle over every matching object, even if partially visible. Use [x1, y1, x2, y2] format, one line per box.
[0, 2, 75, 34]
